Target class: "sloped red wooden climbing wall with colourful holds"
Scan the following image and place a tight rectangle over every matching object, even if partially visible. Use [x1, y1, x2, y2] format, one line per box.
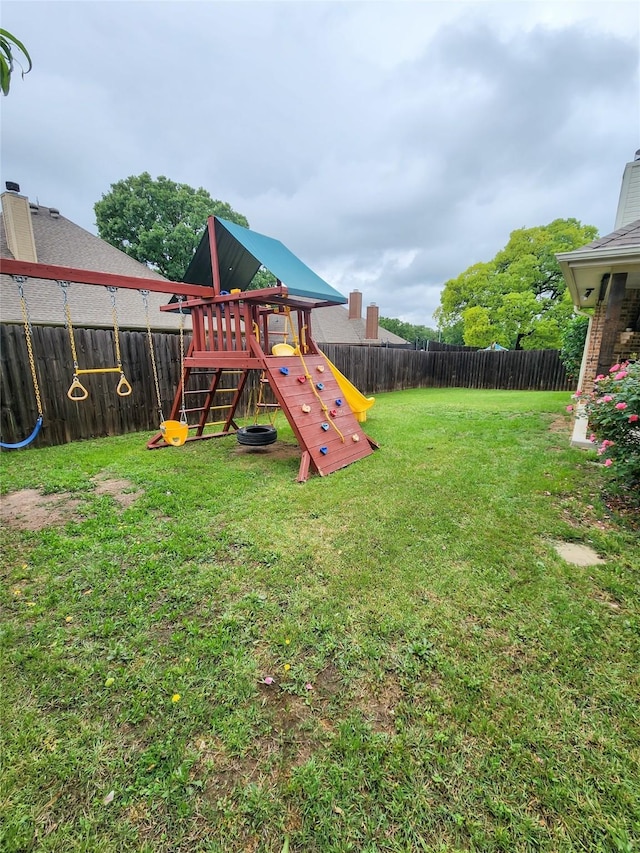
[266, 355, 373, 480]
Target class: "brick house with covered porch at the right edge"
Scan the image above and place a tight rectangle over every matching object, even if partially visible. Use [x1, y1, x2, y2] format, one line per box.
[556, 151, 640, 446]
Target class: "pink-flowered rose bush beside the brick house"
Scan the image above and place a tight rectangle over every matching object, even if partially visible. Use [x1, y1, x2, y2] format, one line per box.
[573, 361, 640, 496]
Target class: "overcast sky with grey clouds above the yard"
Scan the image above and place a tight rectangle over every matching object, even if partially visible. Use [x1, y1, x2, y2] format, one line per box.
[0, 0, 640, 325]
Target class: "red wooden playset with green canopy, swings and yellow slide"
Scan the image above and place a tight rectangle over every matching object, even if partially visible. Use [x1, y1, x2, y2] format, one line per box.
[1, 217, 377, 482]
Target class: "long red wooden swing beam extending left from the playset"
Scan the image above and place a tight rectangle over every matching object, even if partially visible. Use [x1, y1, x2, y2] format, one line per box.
[0, 258, 213, 300]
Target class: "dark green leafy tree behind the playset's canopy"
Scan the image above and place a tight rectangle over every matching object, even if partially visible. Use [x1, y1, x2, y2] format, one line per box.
[94, 172, 249, 281]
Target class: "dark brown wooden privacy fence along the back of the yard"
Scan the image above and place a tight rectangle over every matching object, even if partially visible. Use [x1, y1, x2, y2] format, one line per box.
[0, 324, 575, 447]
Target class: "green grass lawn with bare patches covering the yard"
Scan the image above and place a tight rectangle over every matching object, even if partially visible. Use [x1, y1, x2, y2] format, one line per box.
[0, 389, 640, 853]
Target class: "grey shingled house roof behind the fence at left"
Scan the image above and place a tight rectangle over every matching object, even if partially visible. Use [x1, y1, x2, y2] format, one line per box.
[0, 203, 190, 330]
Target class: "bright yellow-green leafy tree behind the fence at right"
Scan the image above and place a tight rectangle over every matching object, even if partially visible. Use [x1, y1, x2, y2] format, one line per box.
[436, 219, 598, 349]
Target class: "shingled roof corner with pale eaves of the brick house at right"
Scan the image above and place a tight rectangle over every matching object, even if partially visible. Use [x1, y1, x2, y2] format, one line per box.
[556, 219, 640, 308]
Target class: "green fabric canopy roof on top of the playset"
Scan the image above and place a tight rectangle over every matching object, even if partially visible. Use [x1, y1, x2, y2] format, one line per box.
[183, 216, 347, 305]
